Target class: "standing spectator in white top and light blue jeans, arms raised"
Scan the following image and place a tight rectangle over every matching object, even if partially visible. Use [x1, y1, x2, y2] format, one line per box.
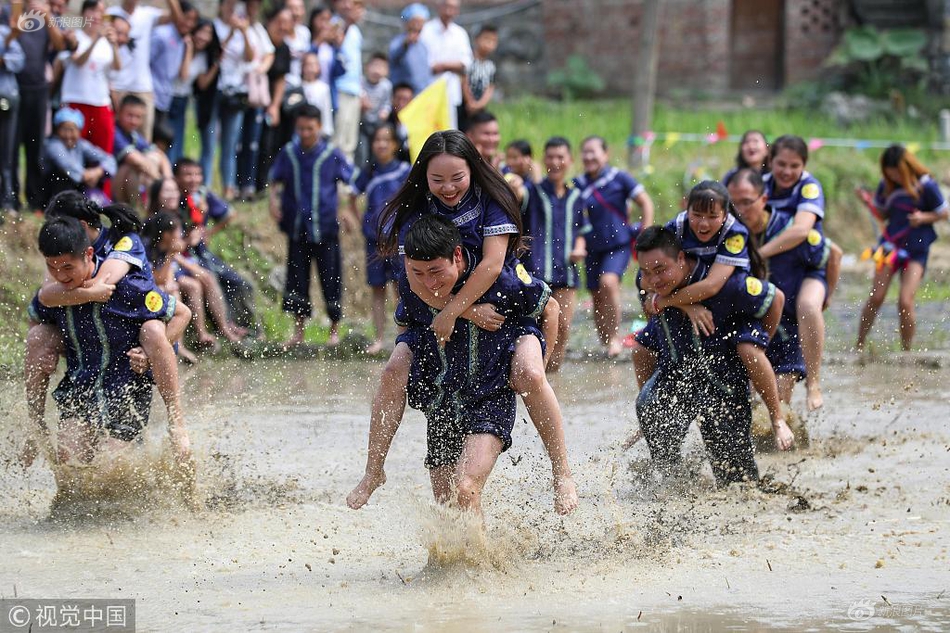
[216, 0, 254, 202]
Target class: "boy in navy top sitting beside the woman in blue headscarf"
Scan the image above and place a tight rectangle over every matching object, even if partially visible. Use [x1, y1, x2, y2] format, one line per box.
[112, 95, 172, 205]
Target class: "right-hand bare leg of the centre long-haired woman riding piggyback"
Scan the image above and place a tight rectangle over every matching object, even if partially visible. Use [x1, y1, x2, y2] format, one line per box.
[509, 335, 578, 514]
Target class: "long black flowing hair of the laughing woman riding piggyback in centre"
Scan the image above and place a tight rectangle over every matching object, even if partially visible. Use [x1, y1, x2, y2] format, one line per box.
[379, 130, 524, 257]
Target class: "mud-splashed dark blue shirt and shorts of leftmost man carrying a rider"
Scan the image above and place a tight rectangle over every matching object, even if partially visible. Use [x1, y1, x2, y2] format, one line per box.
[29, 259, 175, 441]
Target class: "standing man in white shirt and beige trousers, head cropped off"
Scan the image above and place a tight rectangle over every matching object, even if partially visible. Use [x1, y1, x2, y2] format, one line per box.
[108, 0, 183, 142]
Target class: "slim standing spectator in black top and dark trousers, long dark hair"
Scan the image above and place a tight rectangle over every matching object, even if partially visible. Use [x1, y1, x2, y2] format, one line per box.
[255, 4, 294, 192]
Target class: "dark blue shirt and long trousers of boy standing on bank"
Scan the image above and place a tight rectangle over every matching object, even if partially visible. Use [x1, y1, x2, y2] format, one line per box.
[270, 140, 353, 322]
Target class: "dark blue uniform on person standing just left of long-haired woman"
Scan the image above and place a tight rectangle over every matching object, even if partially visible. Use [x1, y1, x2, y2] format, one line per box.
[353, 160, 412, 288]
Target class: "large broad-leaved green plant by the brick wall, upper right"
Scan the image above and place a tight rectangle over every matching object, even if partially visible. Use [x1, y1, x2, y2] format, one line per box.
[825, 26, 930, 97]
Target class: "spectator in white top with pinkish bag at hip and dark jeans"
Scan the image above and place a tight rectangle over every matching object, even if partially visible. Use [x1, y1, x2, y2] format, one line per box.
[237, 0, 283, 200]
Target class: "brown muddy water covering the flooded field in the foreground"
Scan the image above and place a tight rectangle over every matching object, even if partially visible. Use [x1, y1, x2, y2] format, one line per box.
[0, 359, 950, 631]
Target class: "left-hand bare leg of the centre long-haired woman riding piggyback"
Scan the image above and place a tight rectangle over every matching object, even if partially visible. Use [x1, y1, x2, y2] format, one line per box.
[346, 343, 412, 510]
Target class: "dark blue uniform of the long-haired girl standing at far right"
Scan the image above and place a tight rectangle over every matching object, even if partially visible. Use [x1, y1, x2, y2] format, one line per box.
[874, 175, 947, 269]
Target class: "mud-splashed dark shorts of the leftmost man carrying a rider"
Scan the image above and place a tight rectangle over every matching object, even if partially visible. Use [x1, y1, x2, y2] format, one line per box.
[53, 374, 152, 442]
